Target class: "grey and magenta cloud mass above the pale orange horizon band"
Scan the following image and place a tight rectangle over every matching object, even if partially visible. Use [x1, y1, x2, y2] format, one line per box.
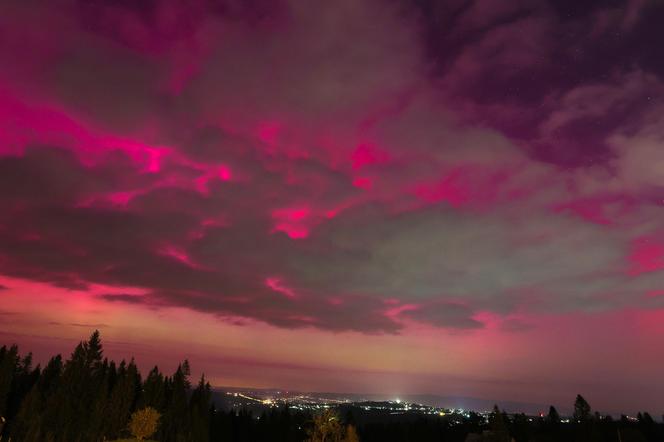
[0, 0, 664, 333]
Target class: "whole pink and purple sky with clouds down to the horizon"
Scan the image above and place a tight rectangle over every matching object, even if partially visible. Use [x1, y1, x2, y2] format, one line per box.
[0, 0, 664, 413]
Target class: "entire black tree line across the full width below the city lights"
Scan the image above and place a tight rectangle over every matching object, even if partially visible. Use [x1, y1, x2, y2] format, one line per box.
[0, 331, 664, 442]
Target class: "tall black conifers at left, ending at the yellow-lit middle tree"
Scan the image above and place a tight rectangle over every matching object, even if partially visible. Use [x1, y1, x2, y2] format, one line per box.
[0, 331, 311, 442]
